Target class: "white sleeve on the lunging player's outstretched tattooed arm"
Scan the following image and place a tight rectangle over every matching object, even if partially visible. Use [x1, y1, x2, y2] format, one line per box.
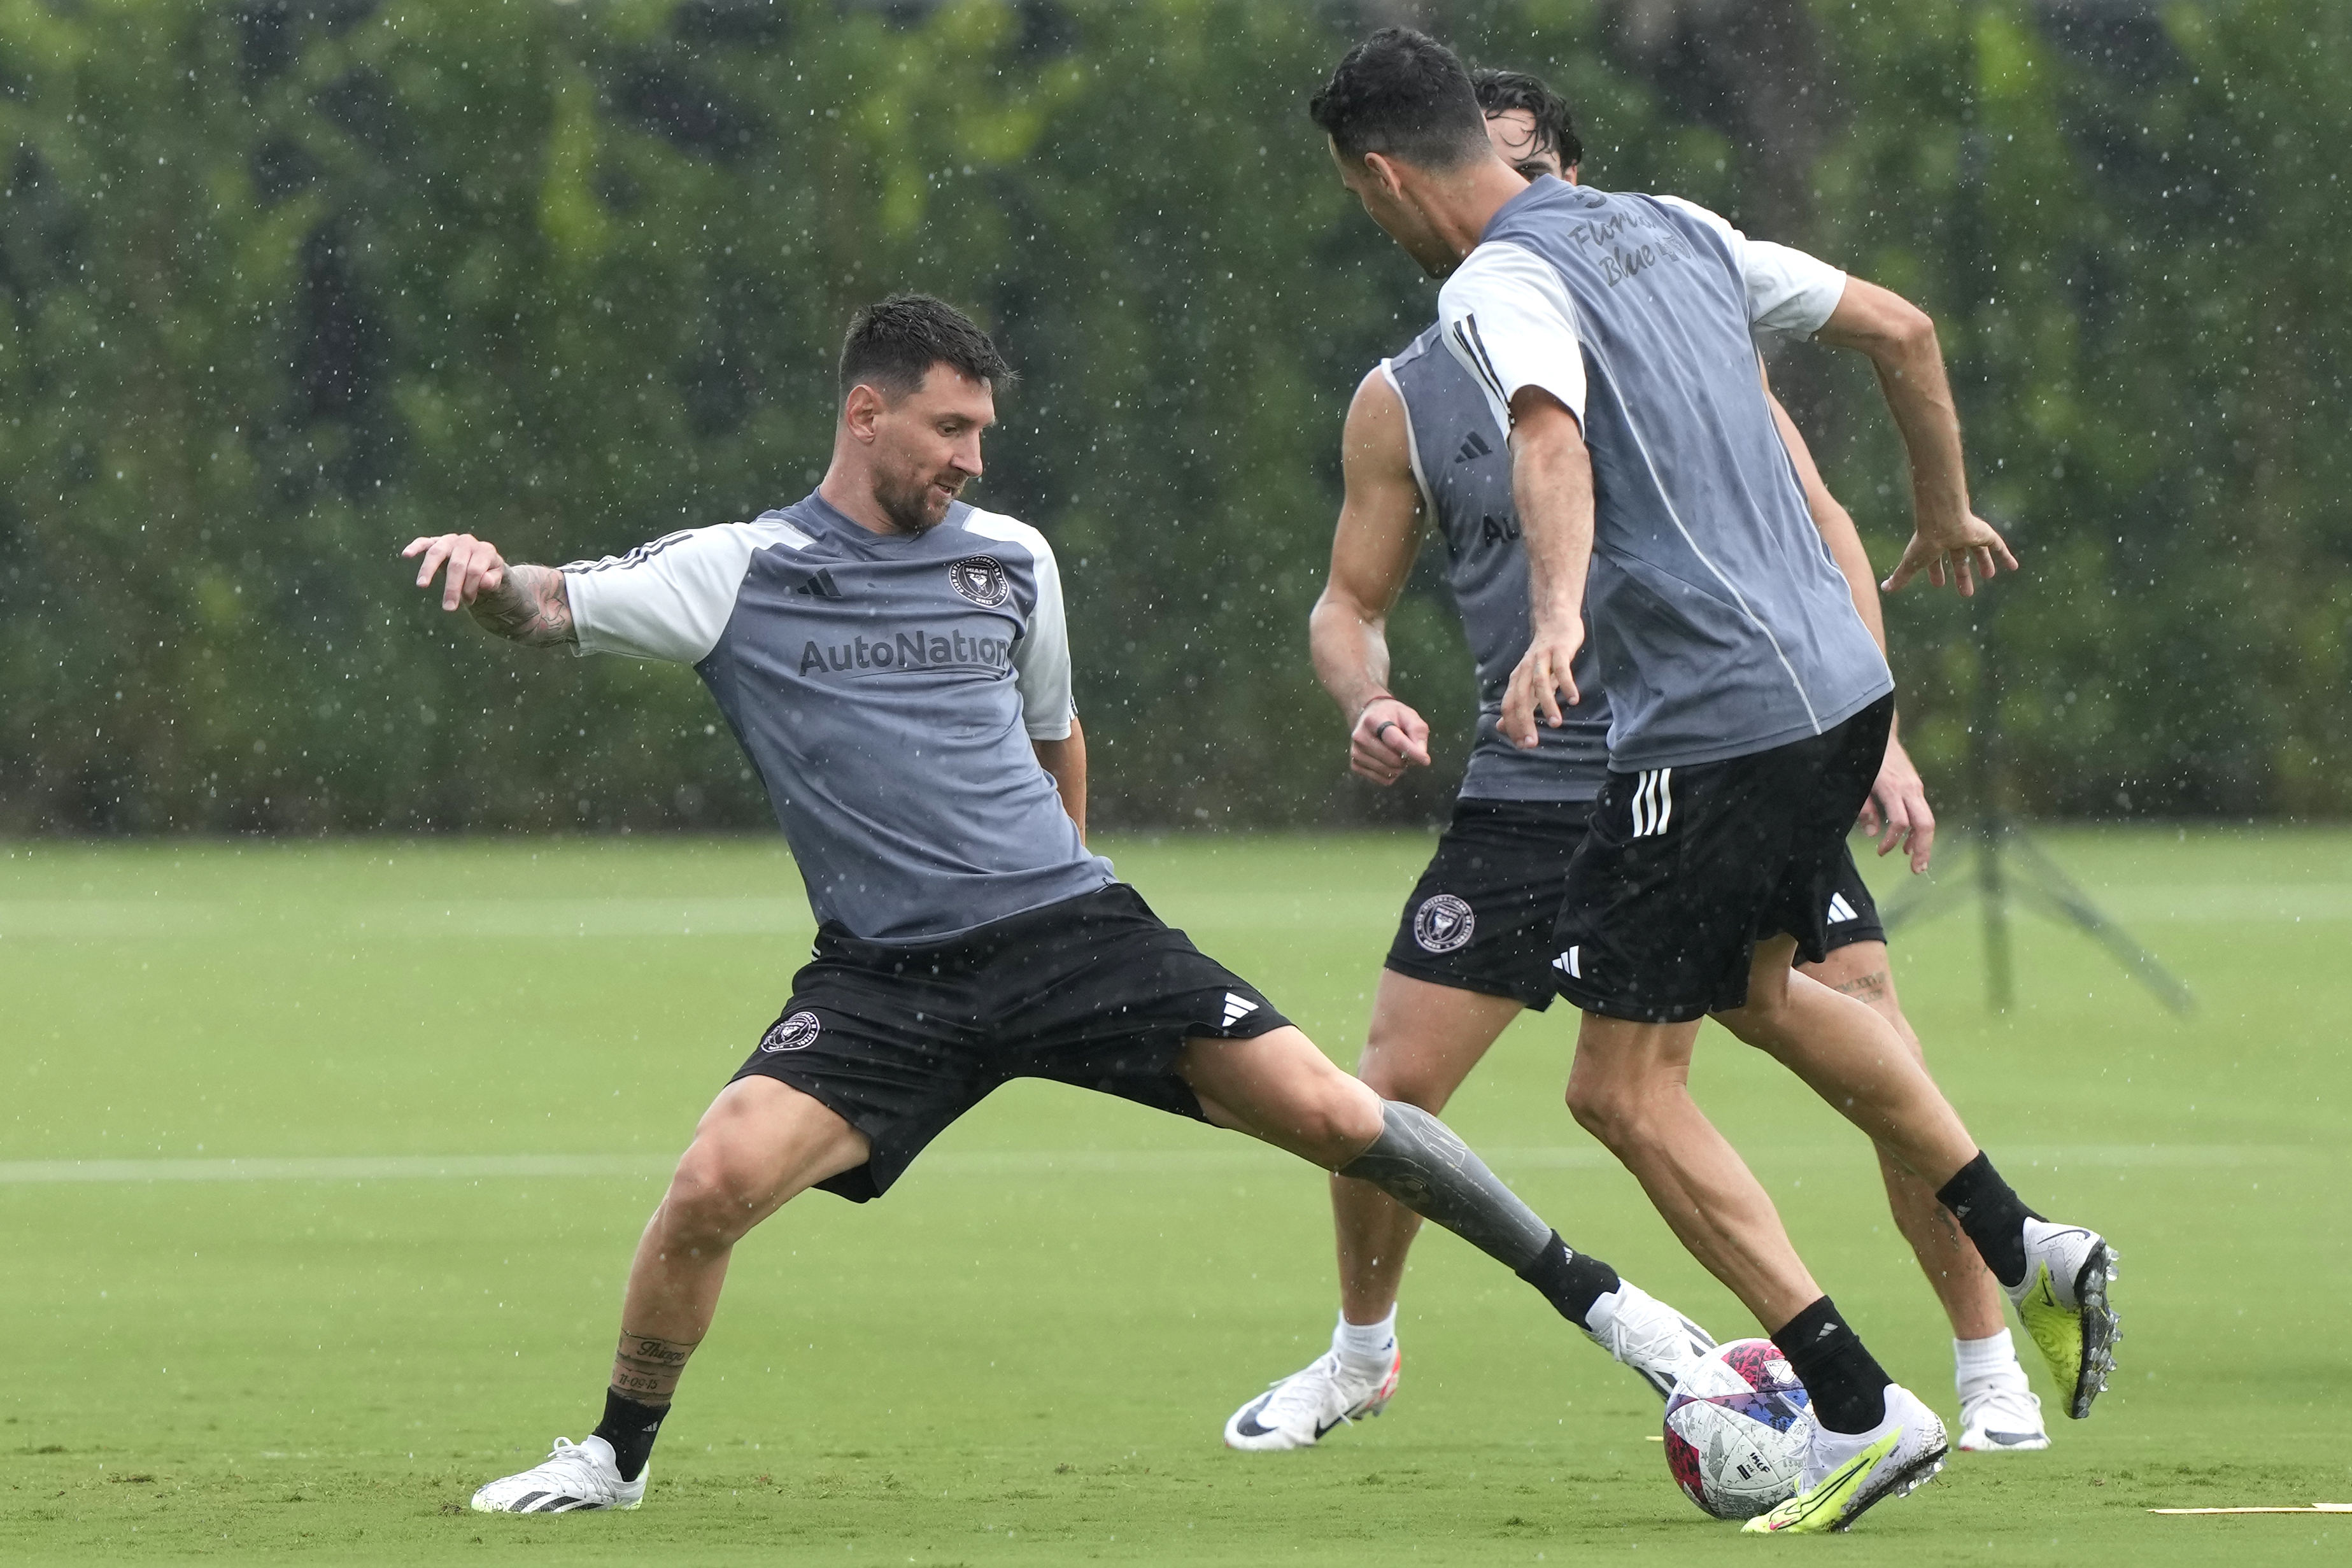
[562, 517, 809, 665]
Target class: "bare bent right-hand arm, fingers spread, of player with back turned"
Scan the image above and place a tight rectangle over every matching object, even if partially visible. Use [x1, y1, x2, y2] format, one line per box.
[1813, 278, 2018, 595]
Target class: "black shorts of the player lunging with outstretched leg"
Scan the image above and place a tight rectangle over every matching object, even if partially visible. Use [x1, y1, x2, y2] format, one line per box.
[736, 882, 1289, 1204]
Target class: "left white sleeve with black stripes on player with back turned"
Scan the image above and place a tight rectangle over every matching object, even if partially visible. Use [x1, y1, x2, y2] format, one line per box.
[1437, 240, 1585, 430]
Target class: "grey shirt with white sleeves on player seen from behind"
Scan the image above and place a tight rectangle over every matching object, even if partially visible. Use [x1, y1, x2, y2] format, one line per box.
[1440, 179, 1894, 773]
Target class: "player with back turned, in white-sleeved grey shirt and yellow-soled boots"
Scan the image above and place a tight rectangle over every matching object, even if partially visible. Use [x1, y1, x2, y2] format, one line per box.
[1312, 28, 2115, 1530]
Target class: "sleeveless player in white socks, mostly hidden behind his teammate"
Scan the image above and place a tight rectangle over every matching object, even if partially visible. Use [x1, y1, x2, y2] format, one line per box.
[1226, 71, 2048, 1453]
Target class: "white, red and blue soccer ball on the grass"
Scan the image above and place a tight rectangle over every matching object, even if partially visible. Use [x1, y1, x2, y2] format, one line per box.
[1665, 1340, 1813, 1518]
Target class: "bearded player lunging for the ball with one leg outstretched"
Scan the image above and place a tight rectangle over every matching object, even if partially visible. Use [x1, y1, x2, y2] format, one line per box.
[404, 294, 1710, 1514]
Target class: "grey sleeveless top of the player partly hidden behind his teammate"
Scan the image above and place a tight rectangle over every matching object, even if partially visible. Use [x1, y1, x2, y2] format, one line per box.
[1380, 327, 1609, 802]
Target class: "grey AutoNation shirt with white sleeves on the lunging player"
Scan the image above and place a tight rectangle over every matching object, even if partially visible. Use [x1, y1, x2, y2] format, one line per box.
[562, 493, 1112, 943]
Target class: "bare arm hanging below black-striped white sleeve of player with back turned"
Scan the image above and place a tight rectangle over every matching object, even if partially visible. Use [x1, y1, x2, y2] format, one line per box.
[1498, 386, 1592, 750]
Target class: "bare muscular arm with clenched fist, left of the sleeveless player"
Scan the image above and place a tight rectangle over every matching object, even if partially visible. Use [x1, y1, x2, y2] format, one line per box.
[1308, 371, 1430, 785]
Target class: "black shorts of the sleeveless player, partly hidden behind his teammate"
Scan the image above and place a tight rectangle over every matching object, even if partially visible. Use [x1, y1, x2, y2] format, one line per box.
[1383, 800, 1887, 1014]
